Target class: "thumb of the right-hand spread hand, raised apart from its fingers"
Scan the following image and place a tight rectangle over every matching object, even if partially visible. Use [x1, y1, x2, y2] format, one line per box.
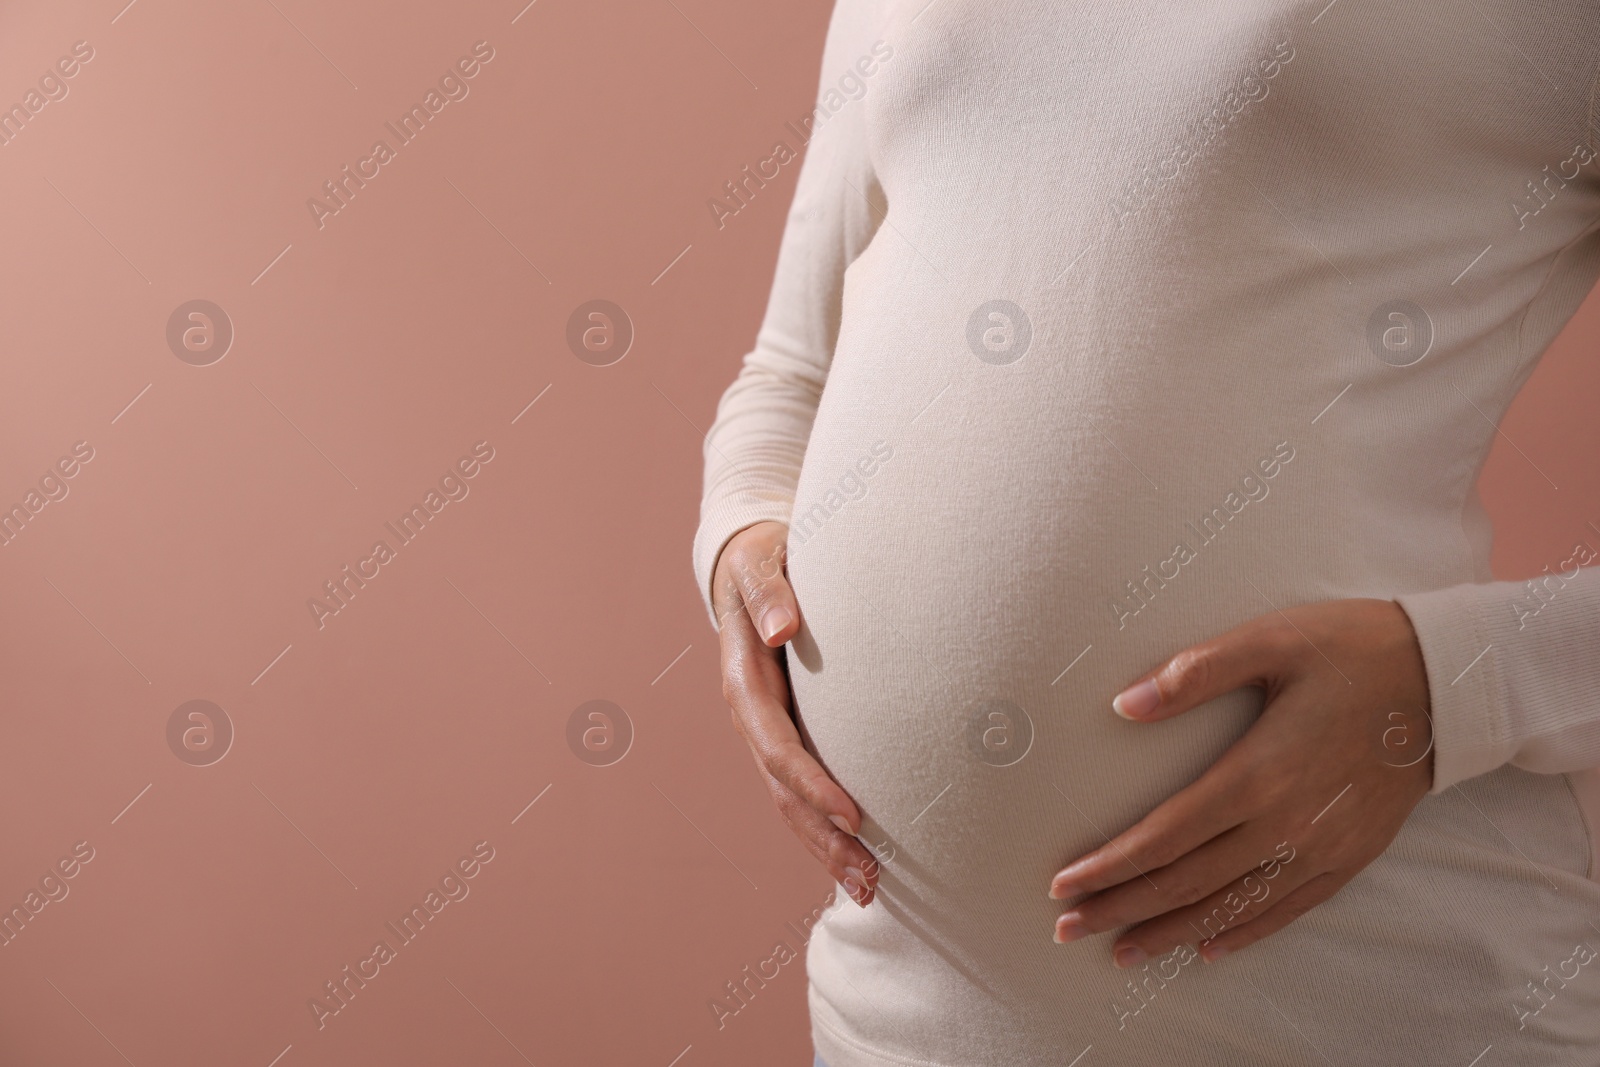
[1110, 616, 1291, 723]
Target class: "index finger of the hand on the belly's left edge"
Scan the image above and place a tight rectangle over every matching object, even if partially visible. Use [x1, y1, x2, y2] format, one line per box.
[722, 591, 861, 835]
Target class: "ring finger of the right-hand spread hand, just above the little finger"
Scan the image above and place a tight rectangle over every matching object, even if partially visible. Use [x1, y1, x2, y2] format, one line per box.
[1112, 869, 1344, 966]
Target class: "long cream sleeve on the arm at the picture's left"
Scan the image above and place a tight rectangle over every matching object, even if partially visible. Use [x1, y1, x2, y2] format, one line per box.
[694, 0, 893, 625]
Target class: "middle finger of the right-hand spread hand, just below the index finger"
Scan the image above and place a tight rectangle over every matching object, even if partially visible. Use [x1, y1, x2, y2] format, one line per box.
[1056, 827, 1272, 944]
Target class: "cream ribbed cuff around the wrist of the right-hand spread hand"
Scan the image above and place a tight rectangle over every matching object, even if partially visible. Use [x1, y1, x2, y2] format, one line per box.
[1395, 584, 1517, 793]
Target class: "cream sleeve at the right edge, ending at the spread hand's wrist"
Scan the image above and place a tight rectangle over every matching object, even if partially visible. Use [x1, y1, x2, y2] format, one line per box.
[1395, 556, 1600, 793]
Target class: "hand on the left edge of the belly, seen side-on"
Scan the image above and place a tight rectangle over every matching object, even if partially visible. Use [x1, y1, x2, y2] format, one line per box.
[712, 522, 878, 907]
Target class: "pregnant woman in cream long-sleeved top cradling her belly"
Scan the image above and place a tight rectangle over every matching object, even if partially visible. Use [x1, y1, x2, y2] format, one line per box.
[694, 0, 1600, 1067]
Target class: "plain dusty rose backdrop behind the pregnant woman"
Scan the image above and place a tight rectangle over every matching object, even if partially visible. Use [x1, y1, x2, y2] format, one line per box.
[0, 0, 1600, 1067]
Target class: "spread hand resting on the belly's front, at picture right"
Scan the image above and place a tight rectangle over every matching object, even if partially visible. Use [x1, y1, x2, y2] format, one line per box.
[1050, 600, 1434, 966]
